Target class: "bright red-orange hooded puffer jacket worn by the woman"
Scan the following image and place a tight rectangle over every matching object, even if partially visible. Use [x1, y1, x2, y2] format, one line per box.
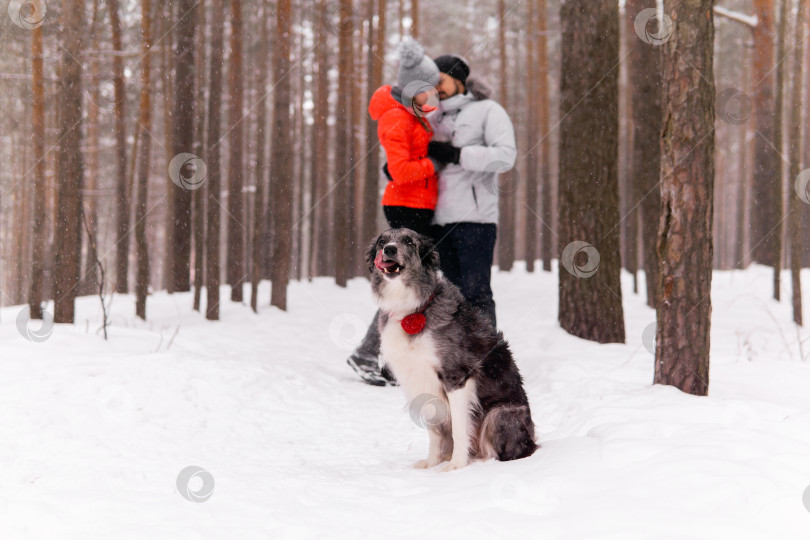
[368, 85, 439, 210]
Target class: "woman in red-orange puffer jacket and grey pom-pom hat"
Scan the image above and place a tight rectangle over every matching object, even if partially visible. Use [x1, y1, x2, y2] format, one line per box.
[368, 40, 439, 235]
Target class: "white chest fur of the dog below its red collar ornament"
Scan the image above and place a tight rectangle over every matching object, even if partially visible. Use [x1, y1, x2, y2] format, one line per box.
[380, 316, 444, 400]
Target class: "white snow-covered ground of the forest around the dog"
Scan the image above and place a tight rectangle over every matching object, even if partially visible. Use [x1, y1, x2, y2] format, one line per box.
[0, 267, 810, 540]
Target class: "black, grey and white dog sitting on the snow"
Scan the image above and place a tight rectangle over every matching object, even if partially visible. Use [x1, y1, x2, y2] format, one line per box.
[366, 229, 537, 471]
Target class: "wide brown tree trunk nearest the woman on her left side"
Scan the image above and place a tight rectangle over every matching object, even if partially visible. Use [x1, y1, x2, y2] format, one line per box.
[268, 0, 292, 311]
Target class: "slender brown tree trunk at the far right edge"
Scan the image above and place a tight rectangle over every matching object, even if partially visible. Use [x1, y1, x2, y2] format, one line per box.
[788, 0, 807, 325]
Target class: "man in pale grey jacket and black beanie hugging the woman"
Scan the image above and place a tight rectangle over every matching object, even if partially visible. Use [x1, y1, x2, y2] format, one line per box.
[428, 55, 517, 327]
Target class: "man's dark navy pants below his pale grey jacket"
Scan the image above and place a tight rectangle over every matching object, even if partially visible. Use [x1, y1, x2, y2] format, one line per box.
[431, 223, 498, 328]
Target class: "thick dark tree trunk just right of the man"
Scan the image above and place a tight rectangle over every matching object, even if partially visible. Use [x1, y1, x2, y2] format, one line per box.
[559, 0, 625, 343]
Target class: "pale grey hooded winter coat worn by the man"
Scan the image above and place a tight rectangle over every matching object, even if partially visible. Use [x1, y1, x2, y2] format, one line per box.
[429, 79, 517, 225]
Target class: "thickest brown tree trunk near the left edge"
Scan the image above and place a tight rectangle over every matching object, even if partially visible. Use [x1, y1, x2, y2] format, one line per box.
[54, 0, 84, 323]
